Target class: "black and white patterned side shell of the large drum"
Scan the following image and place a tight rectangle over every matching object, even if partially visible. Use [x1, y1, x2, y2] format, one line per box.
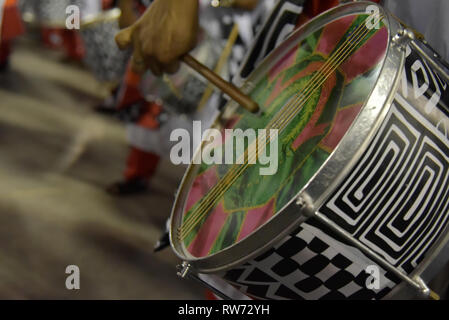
[208, 40, 449, 299]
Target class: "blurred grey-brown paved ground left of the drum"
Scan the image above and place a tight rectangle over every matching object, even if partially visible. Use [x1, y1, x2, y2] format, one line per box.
[0, 40, 203, 299]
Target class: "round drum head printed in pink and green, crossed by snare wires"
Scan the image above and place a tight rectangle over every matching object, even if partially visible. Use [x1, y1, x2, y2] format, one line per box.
[171, 4, 400, 272]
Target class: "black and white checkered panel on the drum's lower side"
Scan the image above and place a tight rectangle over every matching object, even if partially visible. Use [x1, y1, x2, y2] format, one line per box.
[224, 221, 398, 300]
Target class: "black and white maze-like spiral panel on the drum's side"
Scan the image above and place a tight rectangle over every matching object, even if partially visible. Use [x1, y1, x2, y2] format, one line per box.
[320, 99, 449, 273]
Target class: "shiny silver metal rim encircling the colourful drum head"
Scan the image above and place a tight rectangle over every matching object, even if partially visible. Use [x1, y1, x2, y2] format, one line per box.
[170, 1, 405, 273]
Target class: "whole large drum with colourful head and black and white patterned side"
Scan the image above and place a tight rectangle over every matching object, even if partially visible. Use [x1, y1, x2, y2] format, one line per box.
[170, 2, 449, 299]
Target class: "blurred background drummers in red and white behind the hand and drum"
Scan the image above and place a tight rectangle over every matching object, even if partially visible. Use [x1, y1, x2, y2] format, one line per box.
[0, 0, 326, 195]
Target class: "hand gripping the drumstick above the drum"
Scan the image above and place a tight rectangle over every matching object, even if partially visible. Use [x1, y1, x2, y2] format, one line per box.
[115, 0, 199, 76]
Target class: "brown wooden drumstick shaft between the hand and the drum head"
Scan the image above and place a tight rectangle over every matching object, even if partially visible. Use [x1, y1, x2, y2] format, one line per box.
[181, 54, 259, 113]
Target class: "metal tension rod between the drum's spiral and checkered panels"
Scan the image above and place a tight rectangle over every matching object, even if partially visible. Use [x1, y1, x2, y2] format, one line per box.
[296, 194, 440, 300]
